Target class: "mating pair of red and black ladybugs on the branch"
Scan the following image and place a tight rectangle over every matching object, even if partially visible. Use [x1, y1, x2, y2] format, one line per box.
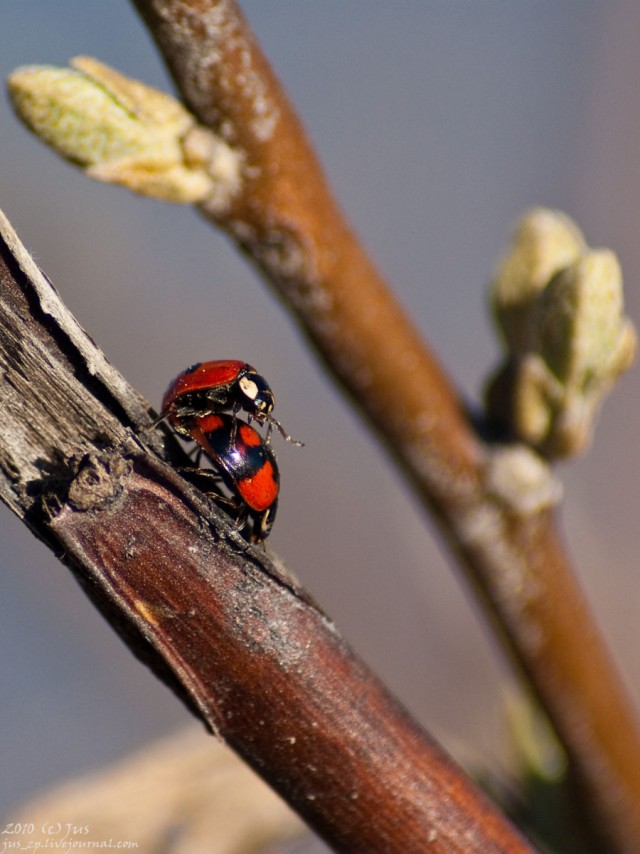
[161, 359, 301, 542]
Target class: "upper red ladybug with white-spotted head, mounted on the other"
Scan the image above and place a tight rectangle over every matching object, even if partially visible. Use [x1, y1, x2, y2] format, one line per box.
[162, 359, 302, 445]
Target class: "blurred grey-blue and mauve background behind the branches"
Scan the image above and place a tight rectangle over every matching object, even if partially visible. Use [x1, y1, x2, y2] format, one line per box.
[0, 0, 640, 844]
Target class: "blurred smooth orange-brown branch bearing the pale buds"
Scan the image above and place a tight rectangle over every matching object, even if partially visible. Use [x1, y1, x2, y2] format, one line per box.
[129, 0, 640, 850]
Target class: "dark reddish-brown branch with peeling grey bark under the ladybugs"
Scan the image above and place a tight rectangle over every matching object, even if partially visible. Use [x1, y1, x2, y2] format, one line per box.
[0, 215, 531, 852]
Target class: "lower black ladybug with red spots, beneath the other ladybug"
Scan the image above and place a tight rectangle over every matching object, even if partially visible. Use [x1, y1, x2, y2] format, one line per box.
[182, 413, 280, 543]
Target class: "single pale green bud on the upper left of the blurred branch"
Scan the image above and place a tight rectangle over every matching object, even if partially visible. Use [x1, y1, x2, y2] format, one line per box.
[8, 57, 239, 204]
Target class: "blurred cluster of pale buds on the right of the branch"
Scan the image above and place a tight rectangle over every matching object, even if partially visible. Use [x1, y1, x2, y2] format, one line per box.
[487, 211, 636, 458]
